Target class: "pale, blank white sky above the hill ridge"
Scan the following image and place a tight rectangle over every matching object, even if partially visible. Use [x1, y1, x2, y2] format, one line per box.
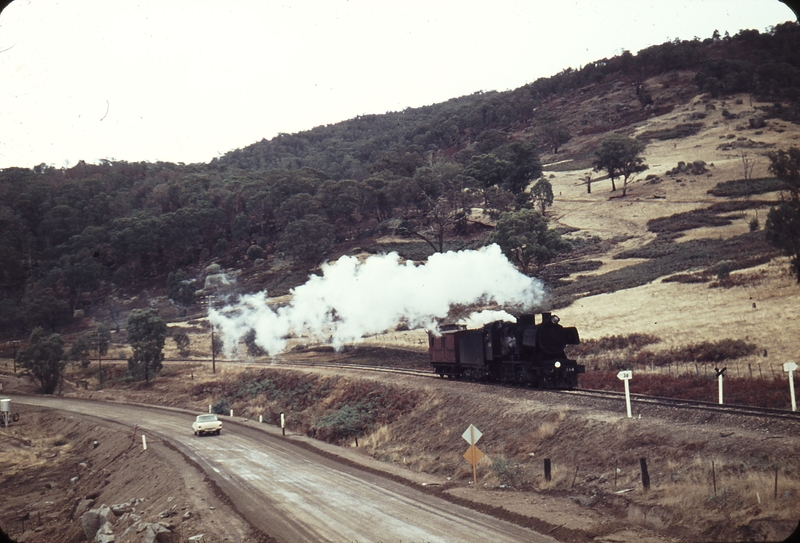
[0, 0, 796, 168]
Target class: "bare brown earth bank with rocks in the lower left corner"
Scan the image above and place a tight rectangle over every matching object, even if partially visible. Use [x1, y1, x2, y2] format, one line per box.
[0, 405, 266, 543]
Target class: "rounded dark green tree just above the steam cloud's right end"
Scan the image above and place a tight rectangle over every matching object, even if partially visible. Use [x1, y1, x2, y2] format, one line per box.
[487, 209, 572, 274]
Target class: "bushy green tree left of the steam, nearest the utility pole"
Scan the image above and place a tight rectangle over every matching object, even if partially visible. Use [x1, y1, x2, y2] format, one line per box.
[128, 309, 167, 382]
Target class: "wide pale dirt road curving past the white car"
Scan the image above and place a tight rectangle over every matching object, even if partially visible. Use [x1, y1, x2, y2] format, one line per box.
[7, 397, 555, 543]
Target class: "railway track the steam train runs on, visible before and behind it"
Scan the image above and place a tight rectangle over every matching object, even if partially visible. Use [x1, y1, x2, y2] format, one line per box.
[270, 362, 800, 422]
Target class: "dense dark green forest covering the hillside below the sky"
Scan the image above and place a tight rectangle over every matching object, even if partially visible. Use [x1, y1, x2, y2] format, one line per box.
[0, 23, 800, 337]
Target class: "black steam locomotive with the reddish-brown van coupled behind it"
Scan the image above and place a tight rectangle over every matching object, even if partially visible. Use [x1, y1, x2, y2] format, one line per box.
[428, 313, 586, 388]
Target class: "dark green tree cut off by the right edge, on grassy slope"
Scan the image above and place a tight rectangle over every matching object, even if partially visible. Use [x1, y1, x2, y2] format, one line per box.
[764, 147, 800, 283]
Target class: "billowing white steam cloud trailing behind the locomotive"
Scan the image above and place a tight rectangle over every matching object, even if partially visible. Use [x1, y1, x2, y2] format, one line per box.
[209, 245, 544, 355]
